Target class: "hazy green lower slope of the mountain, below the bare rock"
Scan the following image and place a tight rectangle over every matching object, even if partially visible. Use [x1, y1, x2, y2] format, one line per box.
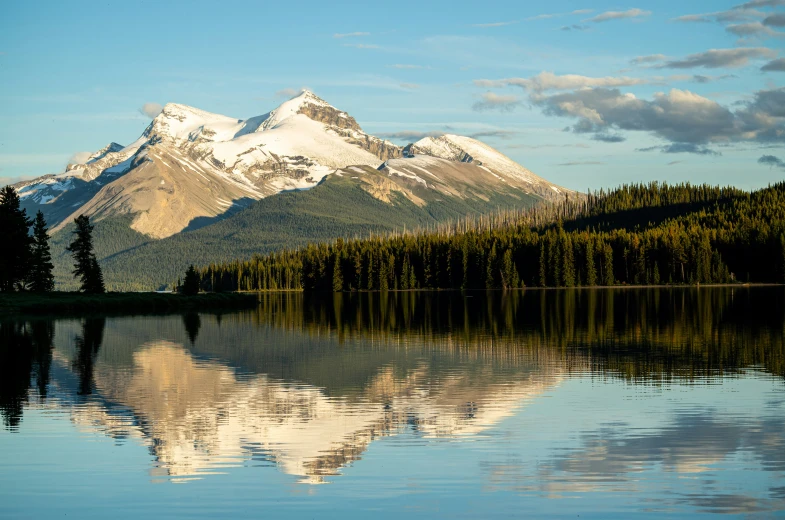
[61, 165, 541, 290]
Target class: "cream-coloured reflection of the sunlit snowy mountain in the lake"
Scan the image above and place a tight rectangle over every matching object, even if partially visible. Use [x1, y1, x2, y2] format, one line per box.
[69, 341, 546, 482]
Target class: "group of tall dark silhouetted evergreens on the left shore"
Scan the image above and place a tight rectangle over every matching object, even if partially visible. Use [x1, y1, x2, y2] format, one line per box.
[0, 186, 105, 294]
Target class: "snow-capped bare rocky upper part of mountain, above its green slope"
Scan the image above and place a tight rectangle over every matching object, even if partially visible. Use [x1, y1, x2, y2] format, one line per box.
[16, 90, 565, 238]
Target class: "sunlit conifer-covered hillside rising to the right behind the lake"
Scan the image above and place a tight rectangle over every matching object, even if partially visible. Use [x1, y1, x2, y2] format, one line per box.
[193, 183, 785, 291]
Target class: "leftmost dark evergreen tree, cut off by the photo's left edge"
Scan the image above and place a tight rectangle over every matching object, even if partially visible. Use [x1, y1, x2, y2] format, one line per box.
[0, 186, 33, 291]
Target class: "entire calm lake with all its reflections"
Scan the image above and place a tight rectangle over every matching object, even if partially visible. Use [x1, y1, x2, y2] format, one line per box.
[0, 287, 785, 519]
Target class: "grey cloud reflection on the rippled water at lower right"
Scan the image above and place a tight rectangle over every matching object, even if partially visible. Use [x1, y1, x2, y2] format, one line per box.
[484, 408, 785, 514]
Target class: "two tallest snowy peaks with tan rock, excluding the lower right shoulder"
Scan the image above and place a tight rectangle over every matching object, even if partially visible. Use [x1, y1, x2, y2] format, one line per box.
[33, 91, 400, 238]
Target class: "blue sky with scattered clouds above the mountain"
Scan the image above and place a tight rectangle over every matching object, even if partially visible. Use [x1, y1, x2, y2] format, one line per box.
[0, 0, 785, 190]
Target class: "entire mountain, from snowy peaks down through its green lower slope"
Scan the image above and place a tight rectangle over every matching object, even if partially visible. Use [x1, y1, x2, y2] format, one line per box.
[16, 91, 569, 290]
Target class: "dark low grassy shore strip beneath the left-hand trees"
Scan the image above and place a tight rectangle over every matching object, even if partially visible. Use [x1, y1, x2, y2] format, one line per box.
[0, 292, 258, 317]
